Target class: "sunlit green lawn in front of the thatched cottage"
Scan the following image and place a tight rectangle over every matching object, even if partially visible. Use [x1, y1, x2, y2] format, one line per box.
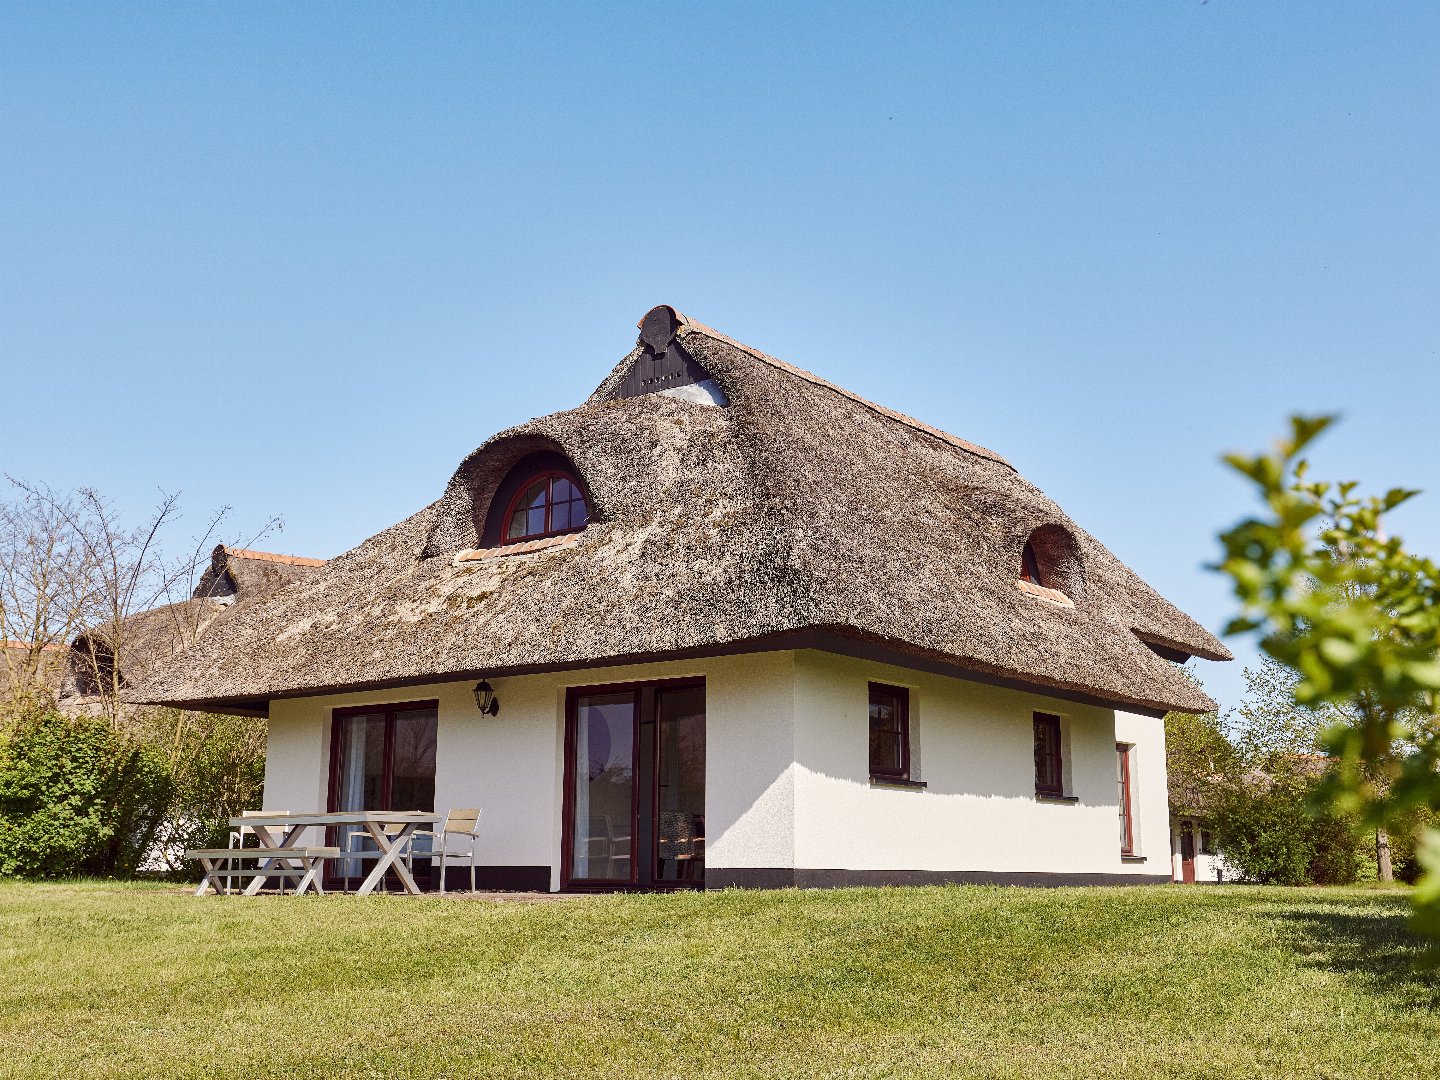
[0, 884, 1440, 1080]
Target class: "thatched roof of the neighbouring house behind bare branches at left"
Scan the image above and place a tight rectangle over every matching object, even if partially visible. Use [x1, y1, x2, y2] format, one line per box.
[59, 544, 325, 713]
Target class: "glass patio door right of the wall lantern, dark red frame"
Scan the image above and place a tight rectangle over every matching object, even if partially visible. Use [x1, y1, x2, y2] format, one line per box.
[563, 680, 706, 888]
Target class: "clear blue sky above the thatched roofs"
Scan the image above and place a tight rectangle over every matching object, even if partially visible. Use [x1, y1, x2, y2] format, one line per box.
[0, 0, 1440, 720]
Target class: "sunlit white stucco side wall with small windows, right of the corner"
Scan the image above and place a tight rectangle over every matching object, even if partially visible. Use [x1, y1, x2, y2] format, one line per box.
[795, 651, 1169, 876]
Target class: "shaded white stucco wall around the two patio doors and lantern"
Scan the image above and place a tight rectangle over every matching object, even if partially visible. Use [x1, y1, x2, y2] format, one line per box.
[265, 652, 795, 888]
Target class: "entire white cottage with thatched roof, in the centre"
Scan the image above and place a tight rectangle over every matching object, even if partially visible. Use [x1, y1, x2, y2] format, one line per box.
[138, 307, 1230, 890]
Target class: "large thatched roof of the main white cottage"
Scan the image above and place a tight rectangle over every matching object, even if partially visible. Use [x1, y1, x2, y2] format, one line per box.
[141, 308, 1230, 713]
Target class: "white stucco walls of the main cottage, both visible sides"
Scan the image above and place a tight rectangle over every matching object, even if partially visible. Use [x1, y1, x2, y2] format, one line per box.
[265, 651, 1169, 888]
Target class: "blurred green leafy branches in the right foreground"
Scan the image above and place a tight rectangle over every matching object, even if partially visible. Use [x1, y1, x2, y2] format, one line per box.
[1221, 418, 1440, 939]
